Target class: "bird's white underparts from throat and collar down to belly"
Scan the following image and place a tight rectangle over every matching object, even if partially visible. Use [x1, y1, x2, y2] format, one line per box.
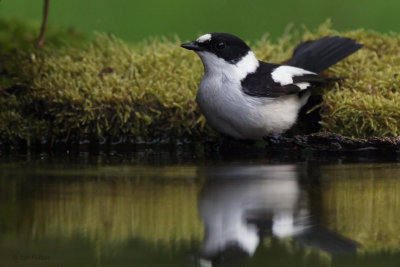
[196, 52, 308, 139]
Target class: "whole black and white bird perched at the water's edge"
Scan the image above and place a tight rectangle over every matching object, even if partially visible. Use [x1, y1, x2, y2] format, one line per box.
[181, 33, 362, 140]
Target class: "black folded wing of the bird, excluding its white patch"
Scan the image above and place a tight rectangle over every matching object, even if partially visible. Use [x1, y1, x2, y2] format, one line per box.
[242, 61, 332, 98]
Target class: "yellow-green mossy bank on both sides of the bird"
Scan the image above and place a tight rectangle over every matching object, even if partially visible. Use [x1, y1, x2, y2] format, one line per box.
[0, 19, 400, 147]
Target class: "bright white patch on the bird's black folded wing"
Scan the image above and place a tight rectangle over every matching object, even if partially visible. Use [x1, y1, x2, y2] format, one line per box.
[271, 66, 316, 90]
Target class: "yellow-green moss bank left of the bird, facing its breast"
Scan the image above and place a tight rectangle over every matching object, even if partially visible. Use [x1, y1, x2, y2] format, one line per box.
[0, 19, 206, 147]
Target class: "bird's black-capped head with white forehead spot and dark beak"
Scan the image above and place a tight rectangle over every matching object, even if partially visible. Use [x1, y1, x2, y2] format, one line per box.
[181, 32, 258, 75]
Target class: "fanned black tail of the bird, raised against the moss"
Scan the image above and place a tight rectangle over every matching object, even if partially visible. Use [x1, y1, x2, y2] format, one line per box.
[287, 36, 363, 73]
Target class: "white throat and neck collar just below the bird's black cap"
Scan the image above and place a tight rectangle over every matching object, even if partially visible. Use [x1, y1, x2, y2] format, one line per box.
[197, 51, 259, 81]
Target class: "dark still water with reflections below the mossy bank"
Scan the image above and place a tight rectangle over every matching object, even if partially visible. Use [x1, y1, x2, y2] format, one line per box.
[0, 156, 400, 266]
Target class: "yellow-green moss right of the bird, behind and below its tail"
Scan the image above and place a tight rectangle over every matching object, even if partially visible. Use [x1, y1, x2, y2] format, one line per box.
[314, 23, 400, 137]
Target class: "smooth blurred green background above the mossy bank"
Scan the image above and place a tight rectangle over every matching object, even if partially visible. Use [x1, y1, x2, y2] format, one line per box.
[0, 0, 400, 42]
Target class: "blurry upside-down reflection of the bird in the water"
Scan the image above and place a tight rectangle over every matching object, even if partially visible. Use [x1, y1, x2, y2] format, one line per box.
[199, 165, 357, 266]
